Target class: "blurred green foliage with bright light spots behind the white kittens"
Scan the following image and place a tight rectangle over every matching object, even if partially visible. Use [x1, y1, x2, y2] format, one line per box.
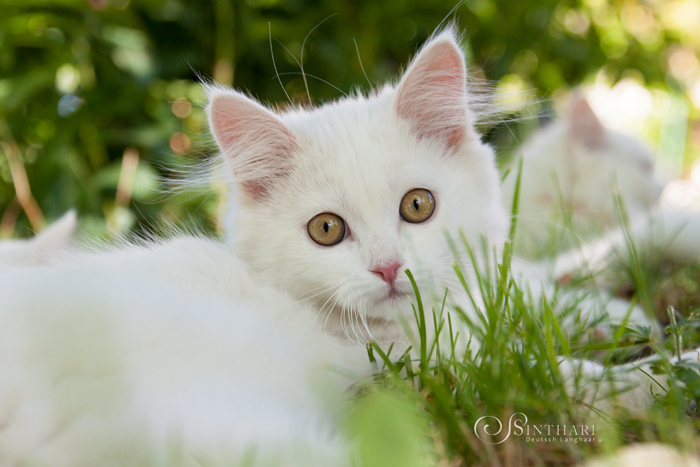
[0, 0, 700, 238]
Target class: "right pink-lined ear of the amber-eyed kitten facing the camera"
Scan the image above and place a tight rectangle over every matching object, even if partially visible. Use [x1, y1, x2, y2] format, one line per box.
[394, 30, 473, 147]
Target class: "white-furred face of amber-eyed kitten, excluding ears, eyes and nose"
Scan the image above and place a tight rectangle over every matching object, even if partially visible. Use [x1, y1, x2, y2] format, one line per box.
[235, 100, 504, 326]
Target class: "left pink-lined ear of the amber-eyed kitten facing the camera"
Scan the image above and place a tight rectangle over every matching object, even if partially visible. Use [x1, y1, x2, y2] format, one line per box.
[207, 88, 297, 200]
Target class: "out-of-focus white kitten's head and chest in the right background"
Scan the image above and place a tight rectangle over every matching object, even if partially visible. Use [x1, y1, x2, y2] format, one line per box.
[503, 97, 663, 257]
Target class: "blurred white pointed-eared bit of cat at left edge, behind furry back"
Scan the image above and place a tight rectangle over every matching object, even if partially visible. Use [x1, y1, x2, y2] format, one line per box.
[0, 211, 77, 265]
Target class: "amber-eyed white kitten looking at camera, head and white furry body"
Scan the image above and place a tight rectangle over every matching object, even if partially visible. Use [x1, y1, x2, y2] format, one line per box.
[0, 27, 700, 466]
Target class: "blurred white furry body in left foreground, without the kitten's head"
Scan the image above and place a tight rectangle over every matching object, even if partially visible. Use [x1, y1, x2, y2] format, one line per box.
[0, 238, 368, 466]
